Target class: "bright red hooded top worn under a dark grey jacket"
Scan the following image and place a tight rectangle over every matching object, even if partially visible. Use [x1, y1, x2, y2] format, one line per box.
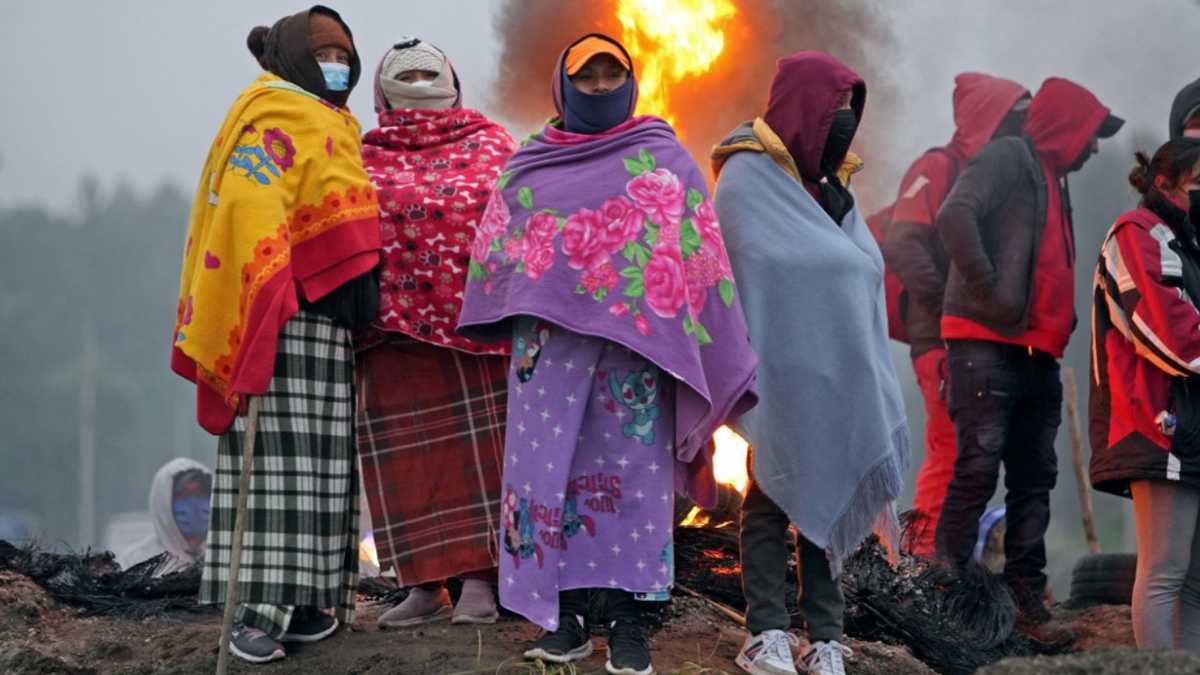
[938, 78, 1109, 358]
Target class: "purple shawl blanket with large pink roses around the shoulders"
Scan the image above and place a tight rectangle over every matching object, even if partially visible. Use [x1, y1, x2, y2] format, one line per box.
[458, 117, 757, 503]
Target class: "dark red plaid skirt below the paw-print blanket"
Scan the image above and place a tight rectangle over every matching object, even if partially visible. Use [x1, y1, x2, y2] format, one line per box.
[356, 338, 509, 586]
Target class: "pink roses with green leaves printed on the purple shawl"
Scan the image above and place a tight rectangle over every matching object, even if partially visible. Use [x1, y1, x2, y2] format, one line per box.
[469, 145, 734, 345]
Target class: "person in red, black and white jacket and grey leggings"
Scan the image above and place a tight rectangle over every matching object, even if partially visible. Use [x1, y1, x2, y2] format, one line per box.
[1088, 138, 1200, 651]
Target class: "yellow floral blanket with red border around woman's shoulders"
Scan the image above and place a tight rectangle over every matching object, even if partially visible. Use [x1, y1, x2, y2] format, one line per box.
[172, 73, 380, 434]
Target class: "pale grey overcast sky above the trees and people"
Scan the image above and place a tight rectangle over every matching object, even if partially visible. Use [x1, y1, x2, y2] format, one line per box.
[0, 0, 1200, 210]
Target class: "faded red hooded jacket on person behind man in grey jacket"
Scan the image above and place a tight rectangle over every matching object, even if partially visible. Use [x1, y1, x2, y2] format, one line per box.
[881, 72, 1030, 358]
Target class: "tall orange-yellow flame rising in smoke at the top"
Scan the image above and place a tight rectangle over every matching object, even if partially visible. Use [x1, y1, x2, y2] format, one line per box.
[617, 0, 737, 126]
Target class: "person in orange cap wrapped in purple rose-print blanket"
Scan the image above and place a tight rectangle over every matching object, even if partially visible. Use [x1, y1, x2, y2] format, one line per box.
[458, 35, 755, 673]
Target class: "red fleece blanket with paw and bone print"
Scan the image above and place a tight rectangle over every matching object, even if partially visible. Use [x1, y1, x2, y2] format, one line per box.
[360, 108, 516, 354]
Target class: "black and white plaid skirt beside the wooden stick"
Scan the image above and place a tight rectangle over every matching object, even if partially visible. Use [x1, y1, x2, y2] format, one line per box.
[200, 311, 359, 628]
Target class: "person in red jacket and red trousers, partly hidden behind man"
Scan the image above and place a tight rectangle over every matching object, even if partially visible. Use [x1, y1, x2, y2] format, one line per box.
[882, 72, 1030, 557]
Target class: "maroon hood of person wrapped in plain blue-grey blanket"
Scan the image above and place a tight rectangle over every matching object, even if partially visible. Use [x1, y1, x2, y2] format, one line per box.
[762, 52, 866, 183]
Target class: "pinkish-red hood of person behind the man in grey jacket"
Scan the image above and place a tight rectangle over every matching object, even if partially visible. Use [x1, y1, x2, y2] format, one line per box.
[950, 72, 1030, 160]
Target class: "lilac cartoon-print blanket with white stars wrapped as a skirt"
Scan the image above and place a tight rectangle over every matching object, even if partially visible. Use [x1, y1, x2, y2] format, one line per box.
[499, 317, 676, 631]
